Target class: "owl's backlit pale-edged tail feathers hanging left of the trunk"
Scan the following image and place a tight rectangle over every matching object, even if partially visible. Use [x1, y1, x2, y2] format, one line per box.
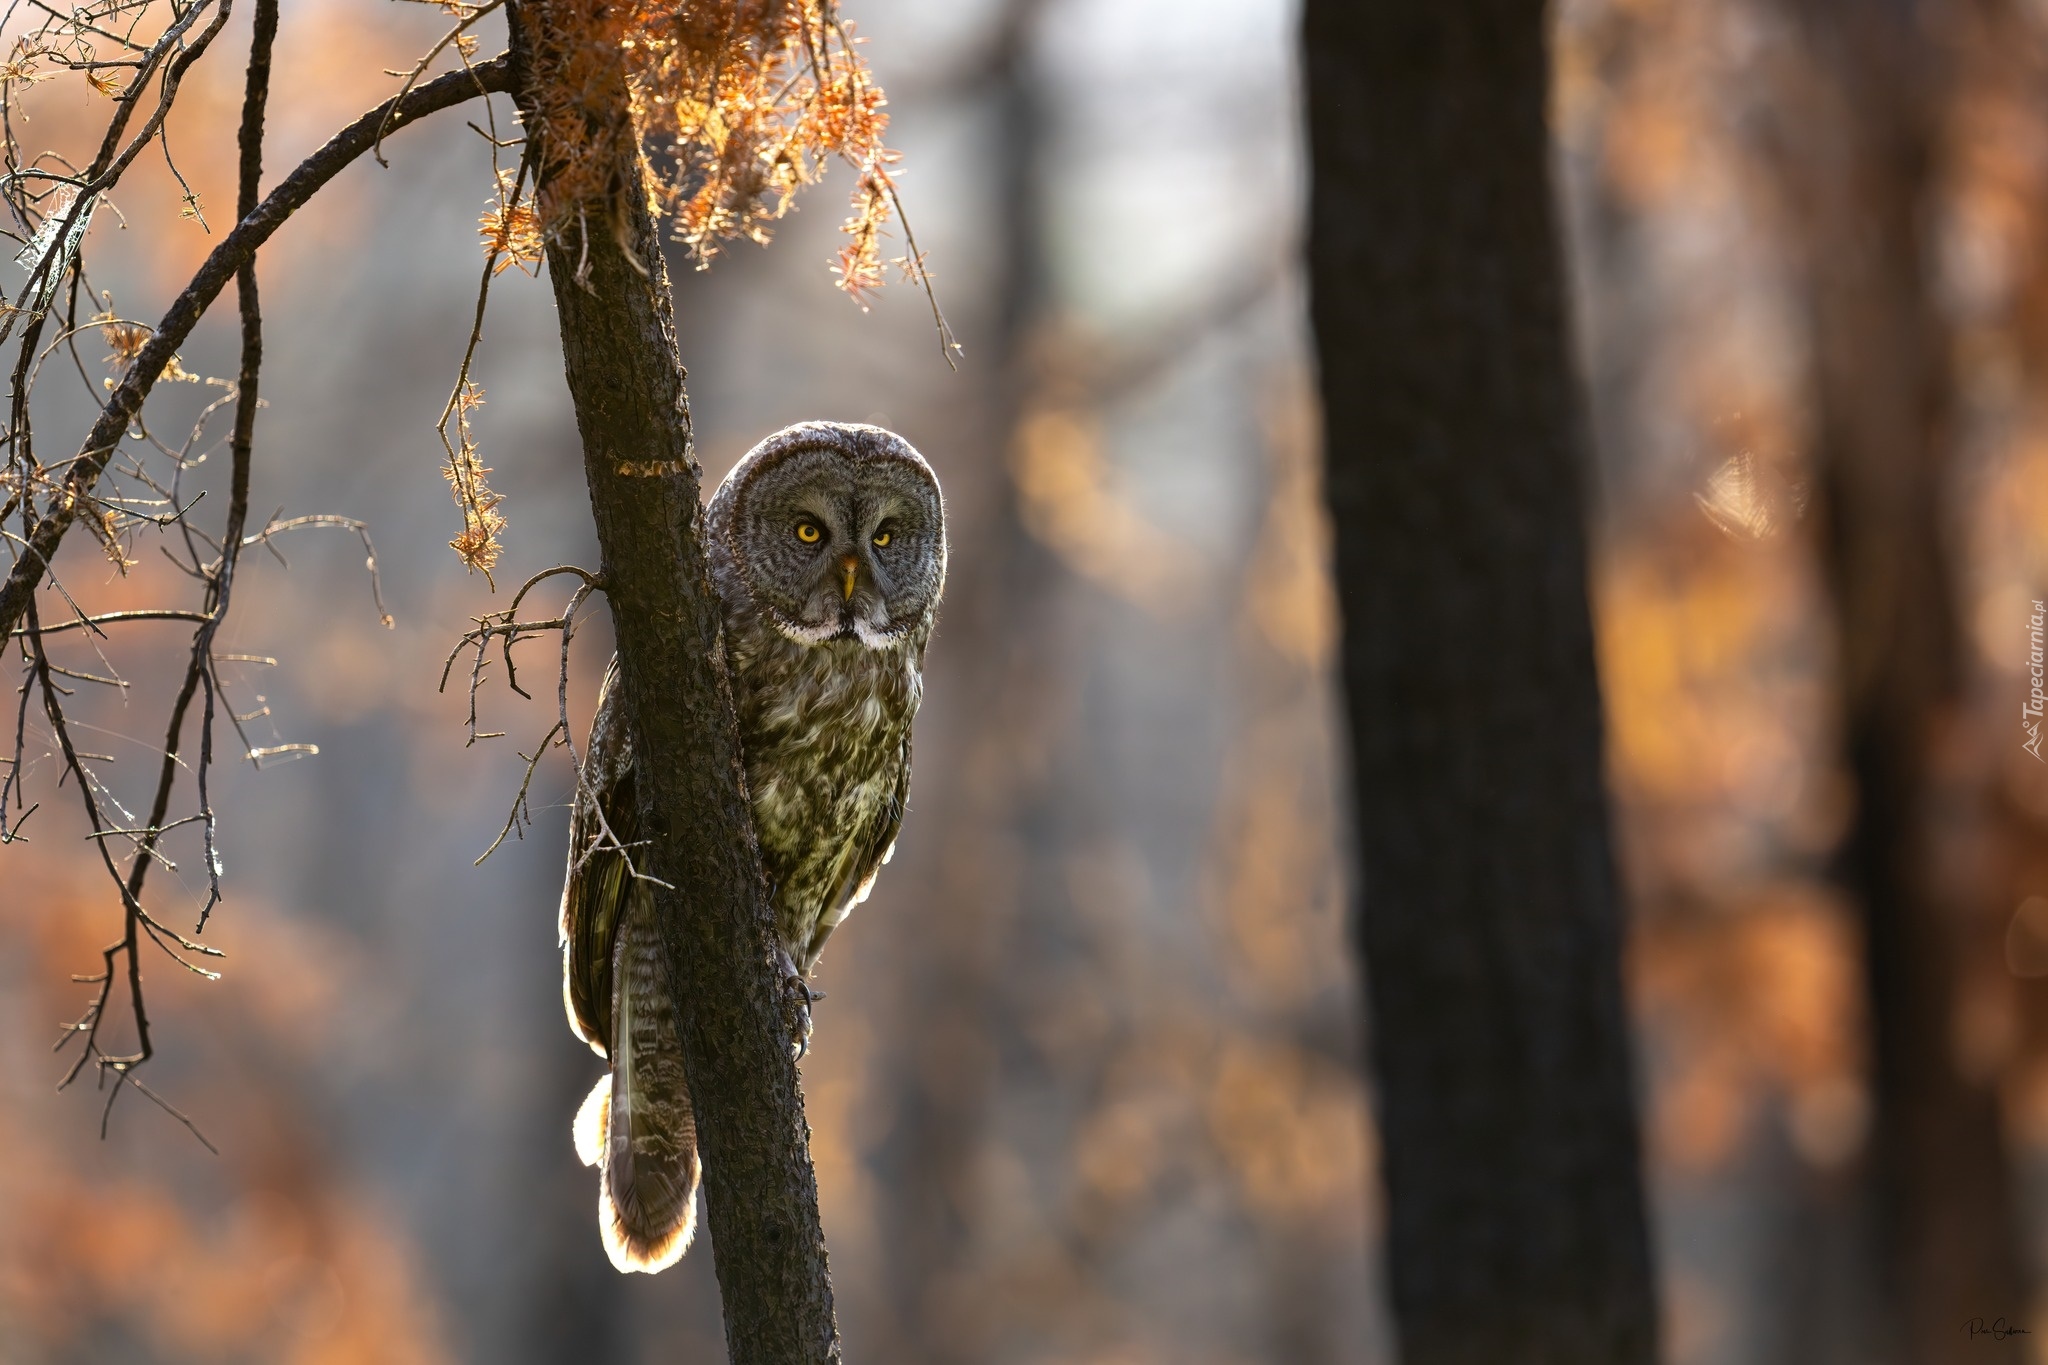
[575, 986, 702, 1275]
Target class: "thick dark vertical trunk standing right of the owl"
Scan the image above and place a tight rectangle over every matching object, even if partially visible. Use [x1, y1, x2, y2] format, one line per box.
[1303, 0, 1657, 1365]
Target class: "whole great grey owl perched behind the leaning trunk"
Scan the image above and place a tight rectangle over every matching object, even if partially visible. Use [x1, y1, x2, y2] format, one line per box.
[561, 422, 946, 1271]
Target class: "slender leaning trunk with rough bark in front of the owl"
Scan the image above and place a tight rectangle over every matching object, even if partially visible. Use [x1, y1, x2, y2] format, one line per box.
[512, 0, 840, 1365]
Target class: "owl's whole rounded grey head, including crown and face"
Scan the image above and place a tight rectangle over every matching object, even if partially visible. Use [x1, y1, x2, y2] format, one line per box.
[709, 422, 946, 649]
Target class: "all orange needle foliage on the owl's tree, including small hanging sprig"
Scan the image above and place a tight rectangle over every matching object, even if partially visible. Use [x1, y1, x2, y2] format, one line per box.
[440, 0, 929, 577]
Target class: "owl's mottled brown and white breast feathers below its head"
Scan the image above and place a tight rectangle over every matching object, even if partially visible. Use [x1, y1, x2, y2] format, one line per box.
[727, 612, 930, 972]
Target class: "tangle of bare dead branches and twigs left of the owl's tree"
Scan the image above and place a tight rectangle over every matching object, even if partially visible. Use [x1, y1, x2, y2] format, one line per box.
[0, 15, 507, 1150]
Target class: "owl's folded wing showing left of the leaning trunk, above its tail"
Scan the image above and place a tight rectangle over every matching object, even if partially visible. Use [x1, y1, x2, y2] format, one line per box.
[561, 659, 639, 1056]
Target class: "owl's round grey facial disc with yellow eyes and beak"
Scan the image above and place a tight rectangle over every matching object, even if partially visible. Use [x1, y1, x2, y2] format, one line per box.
[739, 439, 944, 649]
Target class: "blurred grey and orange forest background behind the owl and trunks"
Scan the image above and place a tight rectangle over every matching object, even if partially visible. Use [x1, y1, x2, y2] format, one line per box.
[0, 0, 2048, 1365]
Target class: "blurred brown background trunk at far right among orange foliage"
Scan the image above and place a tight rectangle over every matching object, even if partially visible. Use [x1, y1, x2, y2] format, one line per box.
[1794, 0, 2025, 1363]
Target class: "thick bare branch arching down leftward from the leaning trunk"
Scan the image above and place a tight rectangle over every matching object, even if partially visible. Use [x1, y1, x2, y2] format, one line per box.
[0, 55, 512, 636]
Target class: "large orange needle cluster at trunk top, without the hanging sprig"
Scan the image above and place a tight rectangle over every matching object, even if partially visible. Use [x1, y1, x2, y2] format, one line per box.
[535, 0, 913, 299]
